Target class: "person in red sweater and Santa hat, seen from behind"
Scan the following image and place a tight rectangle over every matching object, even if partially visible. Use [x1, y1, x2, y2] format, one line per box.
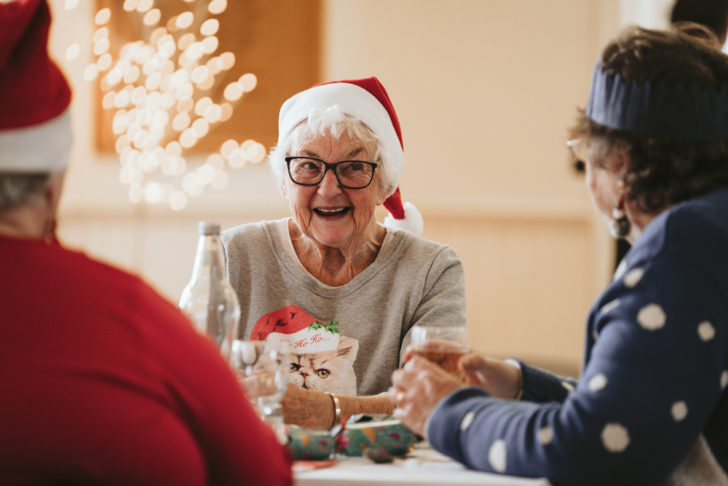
[0, 0, 292, 486]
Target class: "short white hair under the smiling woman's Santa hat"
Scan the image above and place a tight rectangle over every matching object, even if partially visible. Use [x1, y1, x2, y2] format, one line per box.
[268, 105, 398, 196]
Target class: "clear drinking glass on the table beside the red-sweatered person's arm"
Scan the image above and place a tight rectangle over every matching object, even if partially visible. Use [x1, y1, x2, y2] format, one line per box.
[230, 339, 289, 444]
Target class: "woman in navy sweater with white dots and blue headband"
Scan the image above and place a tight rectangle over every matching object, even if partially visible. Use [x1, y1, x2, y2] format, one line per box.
[393, 25, 728, 486]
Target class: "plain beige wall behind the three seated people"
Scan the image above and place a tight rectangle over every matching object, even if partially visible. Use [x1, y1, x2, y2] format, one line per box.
[52, 0, 670, 374]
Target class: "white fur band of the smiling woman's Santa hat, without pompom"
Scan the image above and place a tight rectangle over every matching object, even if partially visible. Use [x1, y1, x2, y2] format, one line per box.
[278, 82, 404, 196]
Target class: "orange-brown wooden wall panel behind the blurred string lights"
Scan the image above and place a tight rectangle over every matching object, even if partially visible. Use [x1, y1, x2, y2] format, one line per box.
[94, 0, 321, 153]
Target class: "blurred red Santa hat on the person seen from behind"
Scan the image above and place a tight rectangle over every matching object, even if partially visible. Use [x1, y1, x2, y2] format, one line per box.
[0, 0, 71, 172]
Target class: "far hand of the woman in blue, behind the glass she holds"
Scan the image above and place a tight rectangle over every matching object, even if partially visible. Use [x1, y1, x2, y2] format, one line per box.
[458, 352, 523, 399]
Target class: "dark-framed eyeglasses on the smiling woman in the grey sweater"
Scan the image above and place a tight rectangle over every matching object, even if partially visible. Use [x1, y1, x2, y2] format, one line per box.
[284, 157, 379, 189]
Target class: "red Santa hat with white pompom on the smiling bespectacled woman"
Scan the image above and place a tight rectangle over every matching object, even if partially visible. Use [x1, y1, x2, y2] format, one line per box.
[278, 77, 423, 235]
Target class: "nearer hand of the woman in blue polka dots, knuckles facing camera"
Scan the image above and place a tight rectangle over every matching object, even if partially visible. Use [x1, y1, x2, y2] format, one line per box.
[392, 356, 464, 435]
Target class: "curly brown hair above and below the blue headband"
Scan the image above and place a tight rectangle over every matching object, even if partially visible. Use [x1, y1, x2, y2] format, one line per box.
[570, 23, 728, 214]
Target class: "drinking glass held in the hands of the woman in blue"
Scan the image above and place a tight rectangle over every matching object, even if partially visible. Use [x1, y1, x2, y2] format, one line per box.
[410, 325, 468, 375]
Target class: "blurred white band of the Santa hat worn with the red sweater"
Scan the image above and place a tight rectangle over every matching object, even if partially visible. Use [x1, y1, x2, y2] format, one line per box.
[0, 109, 72, 172]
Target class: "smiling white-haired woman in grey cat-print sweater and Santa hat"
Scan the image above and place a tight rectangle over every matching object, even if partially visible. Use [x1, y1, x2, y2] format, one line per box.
[222, 78, 465, 428]
